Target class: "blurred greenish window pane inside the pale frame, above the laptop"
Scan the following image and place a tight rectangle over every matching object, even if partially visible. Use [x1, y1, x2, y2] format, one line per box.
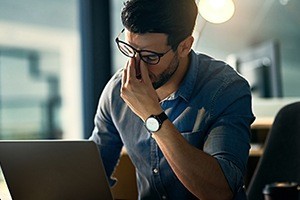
[0, 48, 62, 139]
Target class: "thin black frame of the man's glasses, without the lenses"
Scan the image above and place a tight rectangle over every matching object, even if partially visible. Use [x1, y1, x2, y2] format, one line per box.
[115, 29, 172, 65]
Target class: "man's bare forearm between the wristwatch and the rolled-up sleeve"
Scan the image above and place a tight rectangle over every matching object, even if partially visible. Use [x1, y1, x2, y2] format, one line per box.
[153, 120, 232, 199]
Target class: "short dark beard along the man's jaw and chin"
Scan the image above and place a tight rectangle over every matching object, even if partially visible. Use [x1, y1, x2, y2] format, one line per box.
[152, 52, 179, 90]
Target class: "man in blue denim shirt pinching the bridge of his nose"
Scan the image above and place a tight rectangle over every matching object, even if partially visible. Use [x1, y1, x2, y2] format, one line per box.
[91, 0, 254, 200]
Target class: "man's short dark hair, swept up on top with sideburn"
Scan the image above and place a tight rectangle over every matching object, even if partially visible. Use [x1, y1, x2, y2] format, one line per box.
[121, 0, 198, 51]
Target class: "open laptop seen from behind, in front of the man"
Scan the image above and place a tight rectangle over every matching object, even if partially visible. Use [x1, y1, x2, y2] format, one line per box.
[0, 140, 113, 200]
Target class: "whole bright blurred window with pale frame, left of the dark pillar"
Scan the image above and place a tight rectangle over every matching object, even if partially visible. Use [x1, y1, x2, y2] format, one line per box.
[0, 0, 83, 139]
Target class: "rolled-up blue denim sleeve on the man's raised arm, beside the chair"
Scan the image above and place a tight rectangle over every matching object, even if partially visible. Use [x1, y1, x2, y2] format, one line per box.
[203, 81, 255, 194]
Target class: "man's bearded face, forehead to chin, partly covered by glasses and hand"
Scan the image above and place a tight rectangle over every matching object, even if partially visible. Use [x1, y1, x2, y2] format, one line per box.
[125, 30, 179, 89]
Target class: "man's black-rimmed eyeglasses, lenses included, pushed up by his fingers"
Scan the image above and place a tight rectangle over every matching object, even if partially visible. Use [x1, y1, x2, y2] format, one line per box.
[116, 29, 172, 65]
